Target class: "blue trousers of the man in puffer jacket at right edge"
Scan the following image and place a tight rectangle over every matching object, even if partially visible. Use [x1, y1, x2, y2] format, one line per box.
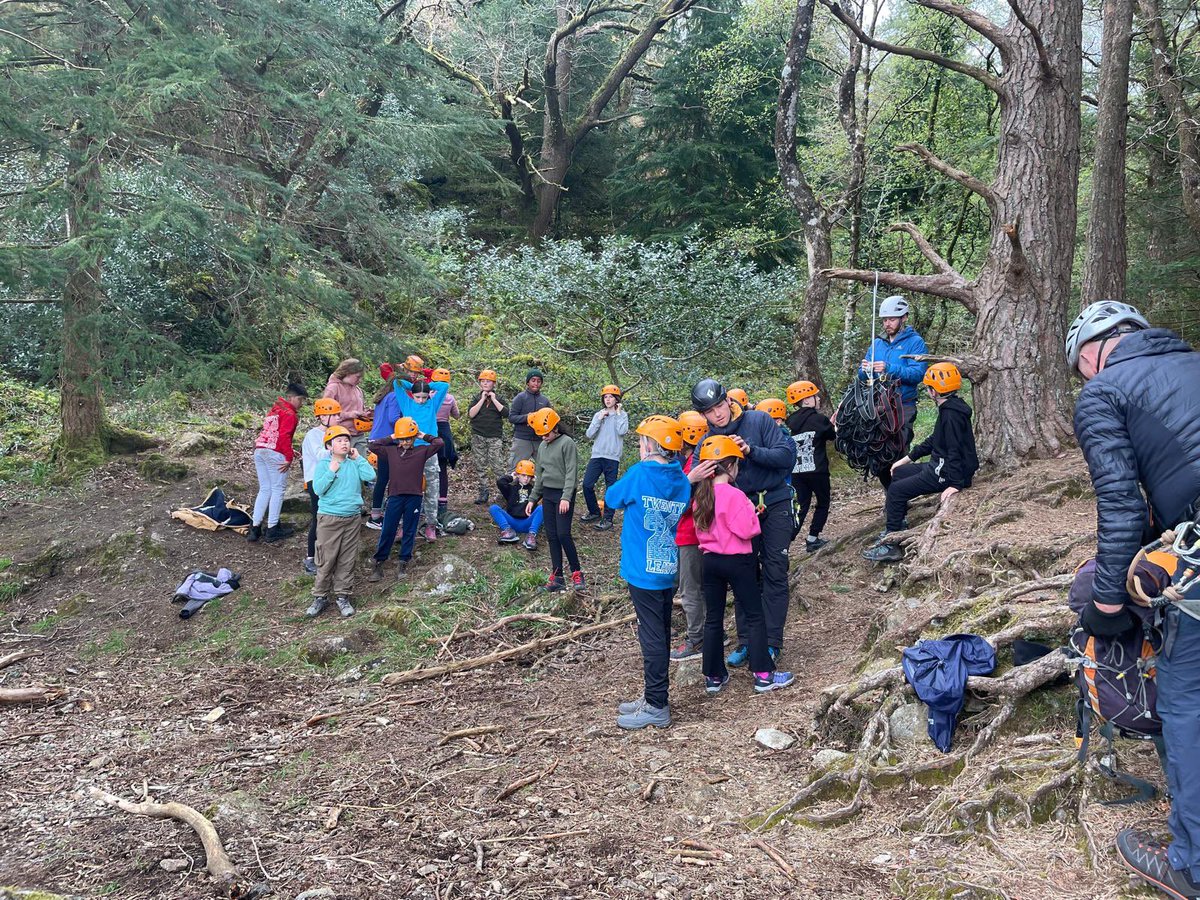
[1156, 610, 1200, 882]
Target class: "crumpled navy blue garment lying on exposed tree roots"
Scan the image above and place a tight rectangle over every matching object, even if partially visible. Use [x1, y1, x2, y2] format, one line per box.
[901, 635, 996, 754]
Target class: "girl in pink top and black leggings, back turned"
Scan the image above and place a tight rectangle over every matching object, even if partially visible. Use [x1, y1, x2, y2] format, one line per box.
[689, 434, 793, 694]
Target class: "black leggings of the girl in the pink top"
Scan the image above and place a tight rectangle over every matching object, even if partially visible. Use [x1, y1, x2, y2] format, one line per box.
[701, 553, 775, 678]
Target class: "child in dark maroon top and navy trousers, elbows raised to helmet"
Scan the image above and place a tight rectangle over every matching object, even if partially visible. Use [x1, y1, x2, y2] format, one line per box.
[367, 416, 442, 582]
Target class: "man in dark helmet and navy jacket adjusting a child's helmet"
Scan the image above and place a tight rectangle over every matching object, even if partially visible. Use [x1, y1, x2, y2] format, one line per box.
[688, 378, 796, 666]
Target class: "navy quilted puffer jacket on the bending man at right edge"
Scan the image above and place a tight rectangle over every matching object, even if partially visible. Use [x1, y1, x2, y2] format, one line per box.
[1075, 329, 1200, 605]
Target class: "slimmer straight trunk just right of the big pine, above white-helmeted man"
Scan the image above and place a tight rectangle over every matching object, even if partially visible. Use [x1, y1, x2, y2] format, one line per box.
[1082, 0, 1133, 306]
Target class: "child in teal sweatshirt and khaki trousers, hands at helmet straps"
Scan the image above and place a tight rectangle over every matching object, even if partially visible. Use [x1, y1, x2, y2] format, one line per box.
[306, 425, 374, 618]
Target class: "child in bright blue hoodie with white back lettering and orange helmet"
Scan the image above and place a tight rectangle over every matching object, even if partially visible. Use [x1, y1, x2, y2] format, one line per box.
[605, 415, 691, 730]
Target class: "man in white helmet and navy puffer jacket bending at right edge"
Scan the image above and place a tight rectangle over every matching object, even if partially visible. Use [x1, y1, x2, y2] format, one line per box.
[1067, 300, 1200, 898]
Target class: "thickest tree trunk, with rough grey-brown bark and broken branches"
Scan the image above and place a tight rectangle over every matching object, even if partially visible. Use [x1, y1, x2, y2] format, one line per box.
[973, 0, 1082, 463]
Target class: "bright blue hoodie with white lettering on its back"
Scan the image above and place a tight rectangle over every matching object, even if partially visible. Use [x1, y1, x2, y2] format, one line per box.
[605, 460, 691, 590]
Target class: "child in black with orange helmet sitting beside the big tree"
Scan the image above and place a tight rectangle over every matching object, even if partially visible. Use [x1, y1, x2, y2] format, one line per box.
[863, 362, 979, 563]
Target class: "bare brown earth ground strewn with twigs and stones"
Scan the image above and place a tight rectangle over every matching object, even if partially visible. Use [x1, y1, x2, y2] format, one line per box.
[0, 427, 1165, 900]
